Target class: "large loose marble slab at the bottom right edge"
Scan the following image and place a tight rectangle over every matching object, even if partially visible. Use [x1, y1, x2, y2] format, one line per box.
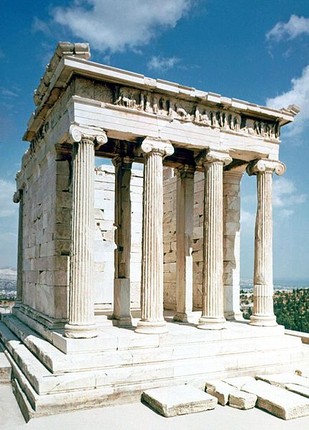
[242, 380, 309, 420]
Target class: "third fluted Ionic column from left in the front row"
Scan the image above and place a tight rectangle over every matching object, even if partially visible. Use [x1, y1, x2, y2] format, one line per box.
[198, 151, 232, 329]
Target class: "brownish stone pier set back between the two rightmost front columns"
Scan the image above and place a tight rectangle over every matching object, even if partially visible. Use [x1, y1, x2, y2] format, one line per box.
[223, 166, 245, 320]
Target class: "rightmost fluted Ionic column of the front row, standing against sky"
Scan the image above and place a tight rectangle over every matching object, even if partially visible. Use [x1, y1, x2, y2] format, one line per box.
[247, 159, 285, 326]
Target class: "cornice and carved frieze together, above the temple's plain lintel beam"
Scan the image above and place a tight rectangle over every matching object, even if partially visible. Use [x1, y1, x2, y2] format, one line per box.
[24, 43, 298, 151]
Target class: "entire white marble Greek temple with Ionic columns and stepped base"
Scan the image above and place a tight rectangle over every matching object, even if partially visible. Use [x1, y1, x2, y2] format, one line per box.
[0, 43, 309, 419]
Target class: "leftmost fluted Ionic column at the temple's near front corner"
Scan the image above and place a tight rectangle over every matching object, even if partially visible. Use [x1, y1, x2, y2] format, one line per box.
[65, 126, 107, 338]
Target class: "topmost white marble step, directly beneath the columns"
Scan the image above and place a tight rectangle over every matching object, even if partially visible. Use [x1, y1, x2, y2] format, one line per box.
[0, 317, 309, 373]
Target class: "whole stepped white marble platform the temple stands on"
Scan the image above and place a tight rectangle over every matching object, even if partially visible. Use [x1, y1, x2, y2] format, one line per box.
[0, 315, 309, 419]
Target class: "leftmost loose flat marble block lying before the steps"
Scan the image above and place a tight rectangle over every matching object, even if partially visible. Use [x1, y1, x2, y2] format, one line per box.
[142, 385, 218, 417]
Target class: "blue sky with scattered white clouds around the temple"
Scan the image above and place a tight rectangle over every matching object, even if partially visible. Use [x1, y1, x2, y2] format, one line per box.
[0, 0, 309, 280]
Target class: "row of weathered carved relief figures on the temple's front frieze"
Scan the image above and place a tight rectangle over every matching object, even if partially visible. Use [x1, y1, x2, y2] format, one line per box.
[114, 87, 279, 140]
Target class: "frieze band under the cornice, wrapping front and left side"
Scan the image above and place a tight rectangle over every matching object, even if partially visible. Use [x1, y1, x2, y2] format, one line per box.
[30, 77, 280, 153]
